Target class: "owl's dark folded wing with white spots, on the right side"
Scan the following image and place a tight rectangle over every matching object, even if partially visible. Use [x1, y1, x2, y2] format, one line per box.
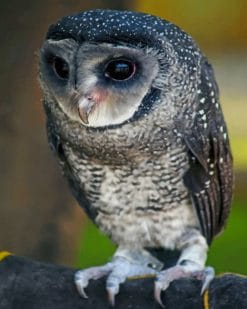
[184, 63, 233, 243]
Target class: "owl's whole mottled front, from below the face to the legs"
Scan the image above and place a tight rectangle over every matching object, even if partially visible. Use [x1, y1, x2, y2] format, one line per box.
[46, 91, 199, 249]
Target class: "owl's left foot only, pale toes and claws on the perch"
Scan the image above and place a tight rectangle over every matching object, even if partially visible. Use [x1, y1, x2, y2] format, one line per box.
[75, 256, 158, 306]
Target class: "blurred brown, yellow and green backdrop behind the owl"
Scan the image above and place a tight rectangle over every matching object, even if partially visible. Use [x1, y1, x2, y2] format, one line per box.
[0, 0, 247, 274]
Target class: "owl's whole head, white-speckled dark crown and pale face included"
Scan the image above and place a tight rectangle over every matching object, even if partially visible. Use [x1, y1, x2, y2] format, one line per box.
[40, 10, 199, 128]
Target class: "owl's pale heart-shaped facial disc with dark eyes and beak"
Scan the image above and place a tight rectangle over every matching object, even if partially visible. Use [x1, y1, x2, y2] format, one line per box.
[40, 39, 159, 127]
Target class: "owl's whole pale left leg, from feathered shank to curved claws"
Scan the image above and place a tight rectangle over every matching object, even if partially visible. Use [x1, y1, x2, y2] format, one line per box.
[75, 248, 163, 305]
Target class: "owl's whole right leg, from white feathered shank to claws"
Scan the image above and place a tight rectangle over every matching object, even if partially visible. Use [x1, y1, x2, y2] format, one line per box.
[154, 231, 214, 307]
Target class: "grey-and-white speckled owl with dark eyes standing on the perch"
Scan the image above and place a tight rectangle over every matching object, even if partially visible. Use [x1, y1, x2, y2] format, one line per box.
[40, 10, 233, 303]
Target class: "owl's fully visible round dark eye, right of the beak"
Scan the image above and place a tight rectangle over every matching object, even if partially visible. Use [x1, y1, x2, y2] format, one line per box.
[105, 59, 136, 81]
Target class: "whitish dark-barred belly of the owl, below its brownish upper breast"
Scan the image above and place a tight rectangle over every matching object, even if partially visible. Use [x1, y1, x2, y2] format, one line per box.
[65, 138, 198, 248]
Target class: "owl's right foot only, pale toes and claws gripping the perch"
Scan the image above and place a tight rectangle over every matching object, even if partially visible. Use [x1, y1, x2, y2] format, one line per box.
[154, 261, 215, 308]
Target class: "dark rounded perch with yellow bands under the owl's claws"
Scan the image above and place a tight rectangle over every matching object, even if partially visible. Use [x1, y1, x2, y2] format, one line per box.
[0, 254, 247, 309]
